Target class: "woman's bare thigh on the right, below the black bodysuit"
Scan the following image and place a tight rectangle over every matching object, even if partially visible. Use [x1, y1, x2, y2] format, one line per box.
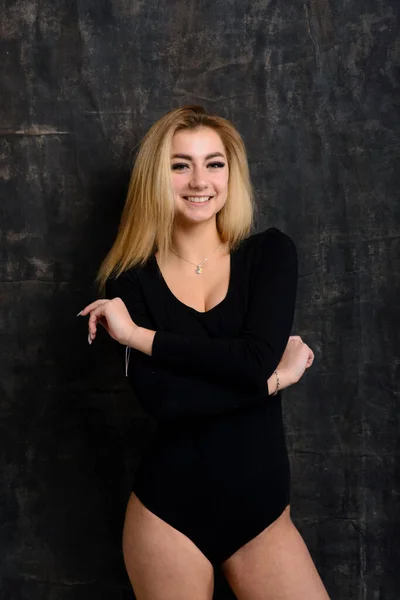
[222, 505, 329, 600]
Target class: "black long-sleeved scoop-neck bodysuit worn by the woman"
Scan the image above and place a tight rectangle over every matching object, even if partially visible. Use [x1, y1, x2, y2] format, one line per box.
[106, 227, 297, 566]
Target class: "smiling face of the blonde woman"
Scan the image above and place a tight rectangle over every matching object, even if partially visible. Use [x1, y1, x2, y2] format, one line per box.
[171, 127, 229, 222]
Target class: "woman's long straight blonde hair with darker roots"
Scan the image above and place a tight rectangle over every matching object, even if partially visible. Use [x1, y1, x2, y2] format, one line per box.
[95, 105, 257, 293]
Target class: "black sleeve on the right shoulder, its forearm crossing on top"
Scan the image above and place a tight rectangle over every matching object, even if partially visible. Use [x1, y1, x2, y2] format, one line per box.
[152, 228, 298, 390]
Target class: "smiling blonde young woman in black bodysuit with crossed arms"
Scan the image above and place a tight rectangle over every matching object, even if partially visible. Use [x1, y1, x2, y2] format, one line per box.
[80, 106, 328, 600]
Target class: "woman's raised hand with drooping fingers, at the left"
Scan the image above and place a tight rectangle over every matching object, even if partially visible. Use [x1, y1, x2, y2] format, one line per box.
[79, 297, 138, 346]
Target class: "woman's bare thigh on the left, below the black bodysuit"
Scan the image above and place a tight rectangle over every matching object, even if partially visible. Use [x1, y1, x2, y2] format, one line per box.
[122, 493, 214, 600]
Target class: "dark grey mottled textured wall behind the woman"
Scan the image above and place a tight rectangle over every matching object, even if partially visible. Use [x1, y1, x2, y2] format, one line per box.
[0, 0, 400, 600]
